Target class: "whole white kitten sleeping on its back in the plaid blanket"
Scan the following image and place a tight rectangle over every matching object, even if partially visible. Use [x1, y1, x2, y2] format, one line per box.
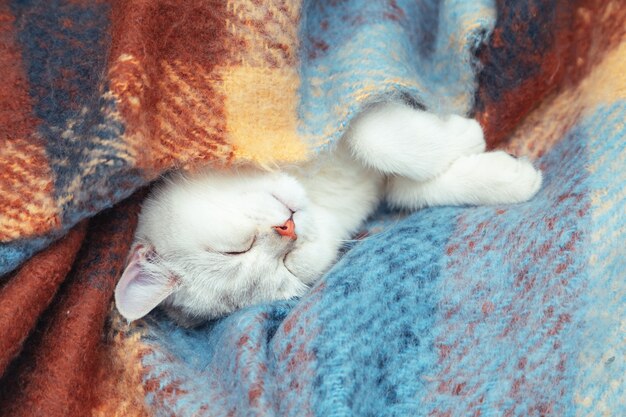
[115, 103, 541, 326]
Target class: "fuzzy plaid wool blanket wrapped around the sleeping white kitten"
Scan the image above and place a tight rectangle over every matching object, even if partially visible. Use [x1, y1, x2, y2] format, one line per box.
[0, 0, 626, 417]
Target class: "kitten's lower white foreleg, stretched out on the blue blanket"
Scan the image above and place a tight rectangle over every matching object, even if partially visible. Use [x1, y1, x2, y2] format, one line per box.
[387, 151, 542, 210]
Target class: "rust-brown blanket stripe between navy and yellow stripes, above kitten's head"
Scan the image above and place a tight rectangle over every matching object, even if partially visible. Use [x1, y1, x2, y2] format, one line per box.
[109, 0, 236, 178]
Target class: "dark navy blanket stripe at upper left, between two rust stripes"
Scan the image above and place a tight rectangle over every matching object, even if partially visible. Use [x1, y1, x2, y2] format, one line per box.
[0, 0, 145, 275]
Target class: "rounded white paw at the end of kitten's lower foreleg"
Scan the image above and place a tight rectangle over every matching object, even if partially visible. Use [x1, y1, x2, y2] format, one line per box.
[450, 151, 542, 204]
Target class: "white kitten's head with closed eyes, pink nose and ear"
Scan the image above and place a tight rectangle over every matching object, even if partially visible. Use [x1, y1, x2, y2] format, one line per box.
[116, 171, 334, 324]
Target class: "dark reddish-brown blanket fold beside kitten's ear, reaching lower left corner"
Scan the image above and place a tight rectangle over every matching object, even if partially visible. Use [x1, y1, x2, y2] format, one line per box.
[0, 193, 143, 417]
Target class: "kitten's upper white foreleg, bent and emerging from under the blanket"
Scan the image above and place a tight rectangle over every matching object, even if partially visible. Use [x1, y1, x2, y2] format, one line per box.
[346, 103, 485, 181]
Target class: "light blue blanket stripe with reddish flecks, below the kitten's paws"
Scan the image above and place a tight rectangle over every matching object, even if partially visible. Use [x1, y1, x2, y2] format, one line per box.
[420, 122, 591, 416]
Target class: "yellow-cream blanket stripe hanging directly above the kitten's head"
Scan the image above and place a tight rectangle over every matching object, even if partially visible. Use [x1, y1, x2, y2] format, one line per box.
[216, 0, 309, 167]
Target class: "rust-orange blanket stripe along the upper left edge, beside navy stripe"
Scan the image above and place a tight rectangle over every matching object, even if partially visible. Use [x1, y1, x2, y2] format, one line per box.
[0, 3, 60, 242]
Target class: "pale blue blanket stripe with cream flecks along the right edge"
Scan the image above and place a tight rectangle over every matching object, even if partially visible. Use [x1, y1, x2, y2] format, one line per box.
[564, 100, 626, 416]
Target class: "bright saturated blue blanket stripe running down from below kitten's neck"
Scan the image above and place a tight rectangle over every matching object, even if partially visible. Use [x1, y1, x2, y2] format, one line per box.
[305, 208, 450, 416]
